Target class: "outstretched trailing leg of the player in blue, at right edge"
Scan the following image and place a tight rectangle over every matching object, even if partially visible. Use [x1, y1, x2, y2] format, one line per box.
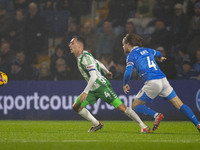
[160, 78, 200, 132]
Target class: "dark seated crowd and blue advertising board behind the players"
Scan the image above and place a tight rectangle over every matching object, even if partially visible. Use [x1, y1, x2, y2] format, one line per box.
[0, 0, 200, 120]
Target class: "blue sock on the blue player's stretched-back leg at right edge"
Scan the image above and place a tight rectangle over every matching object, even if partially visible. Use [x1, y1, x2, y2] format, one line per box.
[180, 104, 199, 126]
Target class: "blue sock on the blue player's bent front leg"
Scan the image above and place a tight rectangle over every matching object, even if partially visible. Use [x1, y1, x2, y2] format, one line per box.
[135, 105, 157, 118]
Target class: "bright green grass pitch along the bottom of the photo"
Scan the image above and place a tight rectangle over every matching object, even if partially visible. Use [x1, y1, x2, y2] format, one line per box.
[0, 121, 200, 150]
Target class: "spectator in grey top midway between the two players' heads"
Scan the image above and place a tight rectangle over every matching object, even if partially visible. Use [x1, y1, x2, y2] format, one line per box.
[96, 21, 116, 58]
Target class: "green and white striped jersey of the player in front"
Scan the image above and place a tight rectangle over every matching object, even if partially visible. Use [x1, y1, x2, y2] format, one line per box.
[77, 51, 107, 91]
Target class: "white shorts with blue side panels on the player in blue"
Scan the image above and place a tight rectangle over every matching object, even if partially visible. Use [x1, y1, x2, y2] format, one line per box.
[136, 78, 176, 102]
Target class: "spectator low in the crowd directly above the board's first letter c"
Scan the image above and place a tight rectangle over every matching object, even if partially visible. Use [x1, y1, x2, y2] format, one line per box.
[38, 62, 53, 80]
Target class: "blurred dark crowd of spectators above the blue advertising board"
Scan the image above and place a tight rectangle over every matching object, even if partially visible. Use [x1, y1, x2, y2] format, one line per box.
[0, 0, 200, 80]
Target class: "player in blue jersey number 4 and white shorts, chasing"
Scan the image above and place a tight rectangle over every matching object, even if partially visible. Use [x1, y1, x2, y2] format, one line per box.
[122, 33, 200, 132]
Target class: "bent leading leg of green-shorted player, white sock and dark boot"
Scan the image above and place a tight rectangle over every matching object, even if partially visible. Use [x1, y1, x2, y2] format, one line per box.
[72, 92, 103, 132]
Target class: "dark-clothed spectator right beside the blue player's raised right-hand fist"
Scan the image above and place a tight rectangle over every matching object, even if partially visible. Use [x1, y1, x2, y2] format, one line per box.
[156, 46, 177, 79]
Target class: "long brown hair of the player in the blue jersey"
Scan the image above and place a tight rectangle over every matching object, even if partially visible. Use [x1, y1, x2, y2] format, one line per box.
[124, 33, 143, 47]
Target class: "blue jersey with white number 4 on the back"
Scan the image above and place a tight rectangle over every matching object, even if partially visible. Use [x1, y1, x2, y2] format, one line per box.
[124, 47, 166, 84]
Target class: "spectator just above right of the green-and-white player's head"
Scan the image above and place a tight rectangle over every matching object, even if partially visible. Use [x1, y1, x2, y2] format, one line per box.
[81, 21, 98, 55]
